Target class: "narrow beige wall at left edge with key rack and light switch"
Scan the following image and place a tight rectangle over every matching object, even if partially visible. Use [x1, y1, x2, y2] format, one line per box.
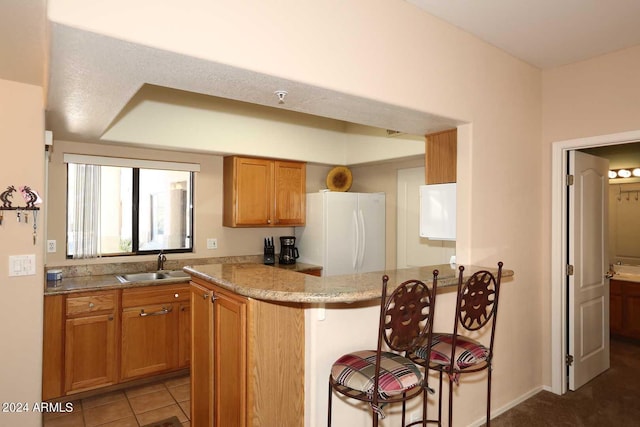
[0, 80, 46, 426]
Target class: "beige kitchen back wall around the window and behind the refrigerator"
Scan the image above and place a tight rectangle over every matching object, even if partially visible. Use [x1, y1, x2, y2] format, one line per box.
[46, 140, 424, 268]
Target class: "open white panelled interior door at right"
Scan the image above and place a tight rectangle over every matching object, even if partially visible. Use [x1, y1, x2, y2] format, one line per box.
[568, 151, 609, 390]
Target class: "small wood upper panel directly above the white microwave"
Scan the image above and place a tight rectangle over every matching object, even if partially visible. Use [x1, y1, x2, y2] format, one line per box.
[425, 129, 458, 184]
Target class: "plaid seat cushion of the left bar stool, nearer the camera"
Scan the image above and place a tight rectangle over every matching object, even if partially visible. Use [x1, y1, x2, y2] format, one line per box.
[331, 350, 423, 398]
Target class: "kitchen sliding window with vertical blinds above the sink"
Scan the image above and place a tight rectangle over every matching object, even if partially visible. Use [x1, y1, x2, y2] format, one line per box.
[65, 154, 199, 259]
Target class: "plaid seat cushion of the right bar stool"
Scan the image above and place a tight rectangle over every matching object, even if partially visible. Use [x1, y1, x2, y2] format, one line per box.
[415, 333, 489, 371]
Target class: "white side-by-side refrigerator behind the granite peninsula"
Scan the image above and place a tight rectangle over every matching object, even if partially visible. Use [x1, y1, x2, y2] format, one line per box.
[296, 191, 385, 276]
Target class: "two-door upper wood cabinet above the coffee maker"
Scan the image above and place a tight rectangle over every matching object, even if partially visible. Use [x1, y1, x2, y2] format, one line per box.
[222, 156, 306, 227]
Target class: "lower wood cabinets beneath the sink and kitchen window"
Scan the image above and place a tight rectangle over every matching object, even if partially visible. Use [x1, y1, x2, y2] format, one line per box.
[42, 284, 191, 400]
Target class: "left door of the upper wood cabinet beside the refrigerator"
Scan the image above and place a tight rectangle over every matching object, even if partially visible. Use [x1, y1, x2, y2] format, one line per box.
[225, 157, 273, 226]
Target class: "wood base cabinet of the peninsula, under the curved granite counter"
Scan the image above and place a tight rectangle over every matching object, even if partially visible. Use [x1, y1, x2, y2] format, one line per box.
[191, 278, 305, 427]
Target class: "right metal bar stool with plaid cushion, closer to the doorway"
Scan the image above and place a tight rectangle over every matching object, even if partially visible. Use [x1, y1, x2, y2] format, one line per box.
[407, 262, 503, 426]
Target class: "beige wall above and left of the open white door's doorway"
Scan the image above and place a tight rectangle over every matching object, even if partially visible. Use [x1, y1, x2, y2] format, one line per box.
[539, 46, 640, 384]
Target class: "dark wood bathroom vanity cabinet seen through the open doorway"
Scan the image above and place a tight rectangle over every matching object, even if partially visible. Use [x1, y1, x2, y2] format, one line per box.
[609, 279, 640, 339]
